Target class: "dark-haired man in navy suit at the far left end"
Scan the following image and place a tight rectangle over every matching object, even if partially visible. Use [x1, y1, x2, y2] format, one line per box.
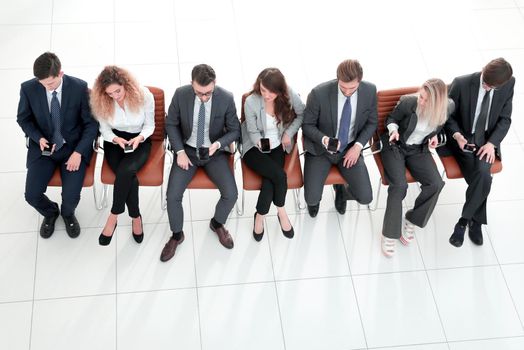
[17, 52, 98, 238]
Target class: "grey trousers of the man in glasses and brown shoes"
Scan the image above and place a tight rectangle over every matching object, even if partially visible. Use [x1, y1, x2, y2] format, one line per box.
[167, 146, 238, 232]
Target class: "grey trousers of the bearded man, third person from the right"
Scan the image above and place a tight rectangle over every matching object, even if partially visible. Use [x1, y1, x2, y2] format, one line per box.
[304, 152, 373, 205]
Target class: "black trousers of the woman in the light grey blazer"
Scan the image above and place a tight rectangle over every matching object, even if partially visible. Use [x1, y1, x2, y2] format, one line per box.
[242, 146, 287, 215]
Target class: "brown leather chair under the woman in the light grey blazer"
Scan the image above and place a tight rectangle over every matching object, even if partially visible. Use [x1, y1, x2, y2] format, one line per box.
[237, 93, 305, 215]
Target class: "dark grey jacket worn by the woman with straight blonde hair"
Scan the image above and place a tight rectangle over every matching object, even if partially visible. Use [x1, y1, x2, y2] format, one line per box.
[385, 95, 455, 145]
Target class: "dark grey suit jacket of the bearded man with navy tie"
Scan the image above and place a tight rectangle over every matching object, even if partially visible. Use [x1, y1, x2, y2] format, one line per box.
[302, 79, 377, 155]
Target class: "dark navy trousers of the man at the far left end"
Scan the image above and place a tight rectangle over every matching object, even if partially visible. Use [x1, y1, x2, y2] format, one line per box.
[25, 143, 87, 217]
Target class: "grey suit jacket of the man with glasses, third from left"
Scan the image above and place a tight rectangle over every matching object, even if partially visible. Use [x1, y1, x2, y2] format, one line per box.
[166, 85, 240, 152]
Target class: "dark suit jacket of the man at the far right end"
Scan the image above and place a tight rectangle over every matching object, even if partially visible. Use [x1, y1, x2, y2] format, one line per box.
[439, 72, 515, 157]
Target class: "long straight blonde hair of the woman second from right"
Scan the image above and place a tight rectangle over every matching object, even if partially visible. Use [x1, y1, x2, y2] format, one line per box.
[416, 79, 448, 128]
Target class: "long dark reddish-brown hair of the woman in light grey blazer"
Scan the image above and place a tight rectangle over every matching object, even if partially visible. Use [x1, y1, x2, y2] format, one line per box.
[251, 68, 297, 126]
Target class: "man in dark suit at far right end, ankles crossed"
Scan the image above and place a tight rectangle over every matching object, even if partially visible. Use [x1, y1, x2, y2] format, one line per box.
[439, 58, 515, 247]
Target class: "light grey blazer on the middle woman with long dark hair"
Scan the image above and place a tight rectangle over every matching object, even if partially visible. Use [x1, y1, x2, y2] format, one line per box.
[241, 89, 305, 156]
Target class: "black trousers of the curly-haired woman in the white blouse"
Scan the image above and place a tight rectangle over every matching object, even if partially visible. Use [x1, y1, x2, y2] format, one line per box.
[104, 130, 151, 218]
